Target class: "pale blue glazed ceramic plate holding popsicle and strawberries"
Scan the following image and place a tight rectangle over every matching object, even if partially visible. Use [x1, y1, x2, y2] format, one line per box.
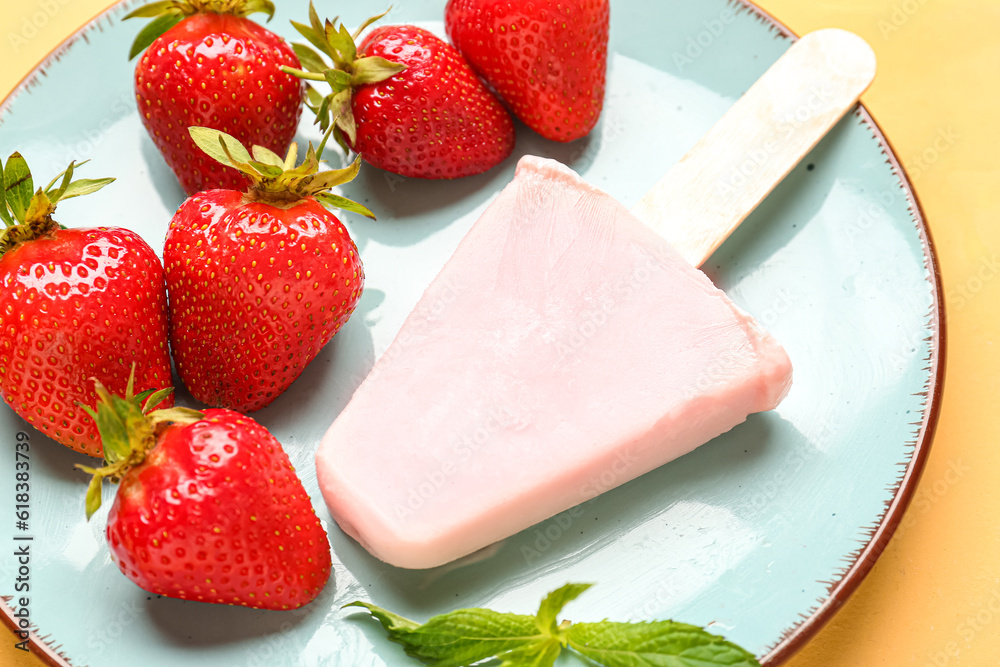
[0, 0, 944, 667]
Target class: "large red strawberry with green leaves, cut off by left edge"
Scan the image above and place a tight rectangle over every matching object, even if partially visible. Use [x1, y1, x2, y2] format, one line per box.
[0, 153, 170, 456]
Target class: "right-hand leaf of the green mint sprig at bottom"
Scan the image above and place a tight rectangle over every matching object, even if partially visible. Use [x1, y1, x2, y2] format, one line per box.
[567, 621, 760, 667]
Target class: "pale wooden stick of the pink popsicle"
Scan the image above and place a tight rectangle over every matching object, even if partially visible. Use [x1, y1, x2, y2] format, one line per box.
[632, 28, 875, 266]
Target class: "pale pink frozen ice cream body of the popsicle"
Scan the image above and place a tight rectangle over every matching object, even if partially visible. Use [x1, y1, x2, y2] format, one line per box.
[316, 31, 870, 568]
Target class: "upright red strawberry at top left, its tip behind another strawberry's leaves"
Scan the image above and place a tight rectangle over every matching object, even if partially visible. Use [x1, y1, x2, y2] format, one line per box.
[125, 0, 302, 195]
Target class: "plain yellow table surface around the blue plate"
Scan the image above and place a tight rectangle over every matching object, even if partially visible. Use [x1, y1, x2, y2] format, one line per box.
[0, 0, 1000, 667]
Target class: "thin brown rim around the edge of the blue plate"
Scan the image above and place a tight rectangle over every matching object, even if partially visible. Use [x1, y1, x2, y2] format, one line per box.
[0, 0, 947, 667]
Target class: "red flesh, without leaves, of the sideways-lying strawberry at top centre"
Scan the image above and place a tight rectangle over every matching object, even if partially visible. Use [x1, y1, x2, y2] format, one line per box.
[352, 25, 514, 178]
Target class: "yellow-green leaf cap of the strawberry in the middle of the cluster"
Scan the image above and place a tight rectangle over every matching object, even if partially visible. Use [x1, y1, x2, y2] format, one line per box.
[189, 127, 375, 220]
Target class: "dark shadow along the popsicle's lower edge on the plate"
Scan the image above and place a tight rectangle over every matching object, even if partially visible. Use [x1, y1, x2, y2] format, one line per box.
[331, 412, 808, 616]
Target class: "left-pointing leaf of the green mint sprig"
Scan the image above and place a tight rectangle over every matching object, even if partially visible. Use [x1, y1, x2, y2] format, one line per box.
[347, 602, 551, 667]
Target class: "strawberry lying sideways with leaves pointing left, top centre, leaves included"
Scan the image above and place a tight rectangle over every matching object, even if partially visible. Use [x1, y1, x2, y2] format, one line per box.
[285, 6, 514, 178]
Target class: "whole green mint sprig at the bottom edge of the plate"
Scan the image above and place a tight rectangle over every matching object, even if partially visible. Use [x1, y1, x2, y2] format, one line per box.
[344, 584, 760, 667]
